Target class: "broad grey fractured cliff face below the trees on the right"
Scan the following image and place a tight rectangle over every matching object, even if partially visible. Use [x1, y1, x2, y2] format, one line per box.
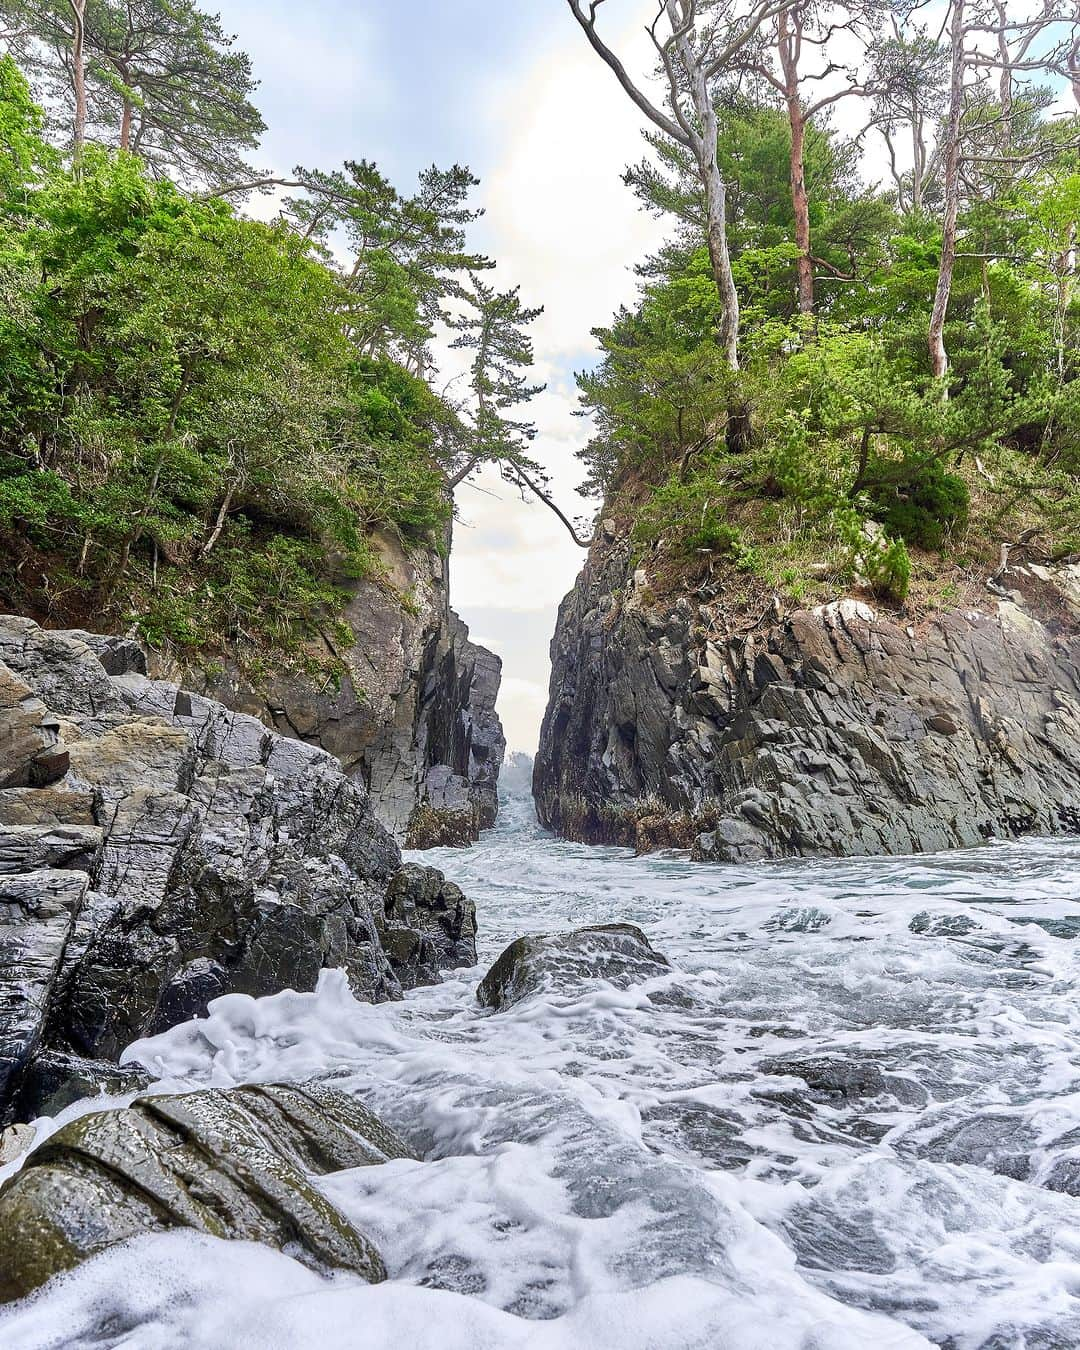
[533, 537, 1080, 860]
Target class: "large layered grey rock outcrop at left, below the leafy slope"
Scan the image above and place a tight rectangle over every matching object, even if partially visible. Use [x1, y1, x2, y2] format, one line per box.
[0, 618, 475, 1125]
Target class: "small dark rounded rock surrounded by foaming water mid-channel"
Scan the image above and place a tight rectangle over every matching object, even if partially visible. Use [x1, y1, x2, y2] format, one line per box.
[477, 923, 671, 1008]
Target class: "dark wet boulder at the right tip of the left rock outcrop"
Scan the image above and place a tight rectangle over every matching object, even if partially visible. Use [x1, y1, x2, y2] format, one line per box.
[382, 863, 477, 990]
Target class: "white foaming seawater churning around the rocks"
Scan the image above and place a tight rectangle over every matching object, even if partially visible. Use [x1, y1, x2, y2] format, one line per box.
[0, 801, 1080, 1350]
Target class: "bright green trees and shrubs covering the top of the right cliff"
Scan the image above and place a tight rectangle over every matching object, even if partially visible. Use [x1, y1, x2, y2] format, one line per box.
[578, 101, 1080, 603]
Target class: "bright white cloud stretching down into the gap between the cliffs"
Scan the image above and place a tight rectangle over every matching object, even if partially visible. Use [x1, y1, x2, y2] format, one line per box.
[440, 7, 662, 749]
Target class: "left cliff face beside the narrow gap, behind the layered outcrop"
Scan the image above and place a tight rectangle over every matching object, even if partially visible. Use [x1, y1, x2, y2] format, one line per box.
[180, 535, 505, 848]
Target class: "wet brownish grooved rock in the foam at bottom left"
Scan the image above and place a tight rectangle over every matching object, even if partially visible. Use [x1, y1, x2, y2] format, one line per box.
[0, 1084, 412, 1301]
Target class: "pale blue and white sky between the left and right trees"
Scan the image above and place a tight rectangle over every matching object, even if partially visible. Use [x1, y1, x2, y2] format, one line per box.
[209, 0, 660, 751]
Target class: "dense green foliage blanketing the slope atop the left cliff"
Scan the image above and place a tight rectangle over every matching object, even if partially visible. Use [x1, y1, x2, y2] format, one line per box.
[0, 73, 456, 664]
